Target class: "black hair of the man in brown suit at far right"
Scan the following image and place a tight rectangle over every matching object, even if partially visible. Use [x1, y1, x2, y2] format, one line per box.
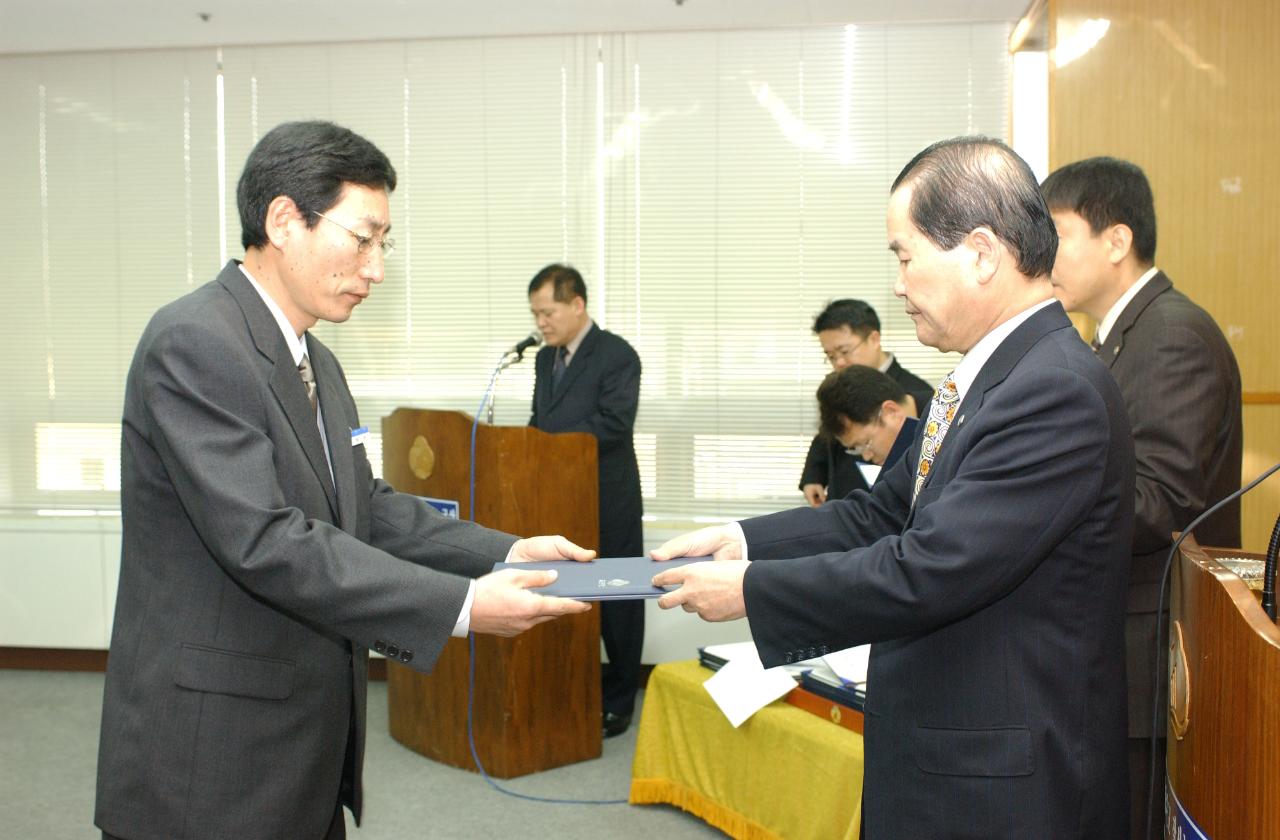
[1041, 158, 1156, 265]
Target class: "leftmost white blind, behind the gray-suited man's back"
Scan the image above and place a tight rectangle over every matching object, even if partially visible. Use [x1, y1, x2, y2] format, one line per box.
[0, 50, 218, 508]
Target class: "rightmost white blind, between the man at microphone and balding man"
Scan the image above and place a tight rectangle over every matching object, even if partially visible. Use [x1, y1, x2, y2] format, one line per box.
[605, 24, 1009, 520]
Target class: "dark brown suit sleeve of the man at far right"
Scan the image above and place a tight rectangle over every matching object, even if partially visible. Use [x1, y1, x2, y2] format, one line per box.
[1125, 319, 1233, 554]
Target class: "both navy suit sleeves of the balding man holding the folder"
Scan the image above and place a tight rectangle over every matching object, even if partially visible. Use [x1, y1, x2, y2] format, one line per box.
[742, 369, 1111, 666]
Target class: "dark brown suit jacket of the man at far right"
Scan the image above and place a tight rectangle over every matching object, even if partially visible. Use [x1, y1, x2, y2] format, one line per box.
[1098, 273, 1243, 738]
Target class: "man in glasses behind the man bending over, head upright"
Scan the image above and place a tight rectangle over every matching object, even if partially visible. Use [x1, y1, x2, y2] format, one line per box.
[800, 298, 933, 507]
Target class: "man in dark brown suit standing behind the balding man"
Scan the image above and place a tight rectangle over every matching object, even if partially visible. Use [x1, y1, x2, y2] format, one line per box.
[1043, 158, 1242, 837]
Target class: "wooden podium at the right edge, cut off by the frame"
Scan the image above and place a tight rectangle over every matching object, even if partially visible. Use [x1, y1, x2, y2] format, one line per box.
[1165, 538, 1280, 840]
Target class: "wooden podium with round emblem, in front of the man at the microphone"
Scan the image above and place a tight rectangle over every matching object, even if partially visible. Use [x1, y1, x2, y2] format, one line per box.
[383, 408, 600, 779]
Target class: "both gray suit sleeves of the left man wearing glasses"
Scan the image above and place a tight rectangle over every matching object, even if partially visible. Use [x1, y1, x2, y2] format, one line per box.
[134, 320, 513, 670]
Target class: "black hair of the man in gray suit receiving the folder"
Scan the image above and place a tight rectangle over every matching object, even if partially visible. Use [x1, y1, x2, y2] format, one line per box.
[236, 120, 396, 248]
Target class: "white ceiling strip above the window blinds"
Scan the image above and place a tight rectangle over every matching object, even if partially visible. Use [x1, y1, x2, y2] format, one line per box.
[0, 0, 1030, 54]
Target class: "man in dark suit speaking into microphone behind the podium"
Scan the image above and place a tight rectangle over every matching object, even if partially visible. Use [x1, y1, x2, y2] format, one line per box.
[529, 264, 644, 738]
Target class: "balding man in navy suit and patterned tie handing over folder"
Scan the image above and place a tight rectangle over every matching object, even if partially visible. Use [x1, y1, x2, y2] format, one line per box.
[654, 137, 1134, 840]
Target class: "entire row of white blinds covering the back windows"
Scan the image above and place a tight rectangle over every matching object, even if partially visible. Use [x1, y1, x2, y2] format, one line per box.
[0, 24, 1009, 521]
